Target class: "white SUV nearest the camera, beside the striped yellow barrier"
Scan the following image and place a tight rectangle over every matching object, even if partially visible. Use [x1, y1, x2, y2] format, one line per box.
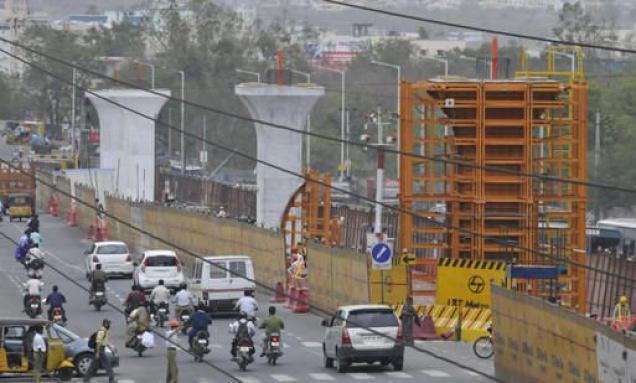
[322, 305, 404, 372]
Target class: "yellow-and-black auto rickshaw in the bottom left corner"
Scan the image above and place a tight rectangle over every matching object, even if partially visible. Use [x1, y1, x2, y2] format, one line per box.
[0, 318, 75, 382]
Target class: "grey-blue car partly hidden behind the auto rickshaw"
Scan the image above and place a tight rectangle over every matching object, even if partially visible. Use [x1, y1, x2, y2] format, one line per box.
[51, 324, 119, 376]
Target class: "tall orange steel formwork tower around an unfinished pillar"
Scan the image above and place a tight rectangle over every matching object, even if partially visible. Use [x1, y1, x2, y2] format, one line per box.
[399, 77, 587, 310]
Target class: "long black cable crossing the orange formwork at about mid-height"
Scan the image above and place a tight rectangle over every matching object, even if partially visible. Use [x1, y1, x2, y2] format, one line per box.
[0, 37, 636, 194]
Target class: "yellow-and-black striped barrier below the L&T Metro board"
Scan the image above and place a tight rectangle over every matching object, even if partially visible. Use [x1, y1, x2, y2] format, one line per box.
[393, 304, 492, 342]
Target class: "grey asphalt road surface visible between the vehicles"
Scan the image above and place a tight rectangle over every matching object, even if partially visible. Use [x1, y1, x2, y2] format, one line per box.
[0, 145, 493, 383]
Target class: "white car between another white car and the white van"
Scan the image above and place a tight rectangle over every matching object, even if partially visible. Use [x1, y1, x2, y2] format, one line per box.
[133, 250, 185, 292]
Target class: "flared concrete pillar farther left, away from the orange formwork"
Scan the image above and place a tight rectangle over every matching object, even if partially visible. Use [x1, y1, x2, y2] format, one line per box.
[86, 89, 170, 201]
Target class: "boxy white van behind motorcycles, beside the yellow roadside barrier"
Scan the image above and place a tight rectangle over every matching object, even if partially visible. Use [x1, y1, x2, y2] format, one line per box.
[189, 255, 256, 314]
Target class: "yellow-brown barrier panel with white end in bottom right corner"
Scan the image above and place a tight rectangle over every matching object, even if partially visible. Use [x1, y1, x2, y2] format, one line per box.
[492, 286, 636, 383]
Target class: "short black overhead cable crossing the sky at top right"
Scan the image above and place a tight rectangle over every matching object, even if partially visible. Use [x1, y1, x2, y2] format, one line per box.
[322, 0, 636, 54]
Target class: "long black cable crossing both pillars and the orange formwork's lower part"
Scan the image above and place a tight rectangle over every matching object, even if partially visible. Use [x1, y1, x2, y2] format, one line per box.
[0, 48, 636, 294]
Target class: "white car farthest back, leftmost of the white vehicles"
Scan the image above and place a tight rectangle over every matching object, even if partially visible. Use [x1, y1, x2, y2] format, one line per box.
[84, 241, 135, 279]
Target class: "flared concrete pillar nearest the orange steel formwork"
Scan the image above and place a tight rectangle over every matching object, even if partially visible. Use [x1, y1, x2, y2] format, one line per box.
[235, 83, 325, 229]
